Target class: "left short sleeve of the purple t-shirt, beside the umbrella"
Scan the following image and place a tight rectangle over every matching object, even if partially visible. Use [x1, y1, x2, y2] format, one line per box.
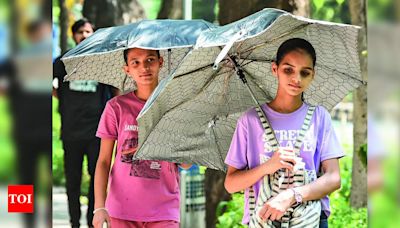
[225, 115, 248, 169]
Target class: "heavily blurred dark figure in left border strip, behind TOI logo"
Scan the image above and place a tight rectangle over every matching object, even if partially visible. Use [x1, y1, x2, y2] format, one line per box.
[0, 19, 52, 227]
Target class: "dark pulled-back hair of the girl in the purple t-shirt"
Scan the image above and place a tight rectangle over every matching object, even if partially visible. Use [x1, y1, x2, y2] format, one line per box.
[275, 38, 317, 66]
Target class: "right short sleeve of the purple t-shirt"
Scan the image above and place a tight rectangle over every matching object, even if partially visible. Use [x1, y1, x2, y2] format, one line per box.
[317, 106, 345, 162]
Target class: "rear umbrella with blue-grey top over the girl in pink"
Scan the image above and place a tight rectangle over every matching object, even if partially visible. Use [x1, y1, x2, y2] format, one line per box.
[62, 20, 215, 91]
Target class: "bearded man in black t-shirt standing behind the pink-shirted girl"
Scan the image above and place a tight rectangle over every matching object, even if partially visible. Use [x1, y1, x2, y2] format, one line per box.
[53, 18, 117, 227]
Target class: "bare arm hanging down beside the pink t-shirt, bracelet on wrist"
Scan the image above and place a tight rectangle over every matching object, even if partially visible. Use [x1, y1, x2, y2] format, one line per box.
[93, 139, 115, 227]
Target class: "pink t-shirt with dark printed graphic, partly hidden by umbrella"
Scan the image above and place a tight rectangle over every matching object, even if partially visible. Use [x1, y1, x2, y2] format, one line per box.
[96, 92, 179, 222]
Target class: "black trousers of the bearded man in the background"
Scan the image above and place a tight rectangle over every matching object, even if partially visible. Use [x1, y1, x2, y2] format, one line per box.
[63, 138, 100, 227]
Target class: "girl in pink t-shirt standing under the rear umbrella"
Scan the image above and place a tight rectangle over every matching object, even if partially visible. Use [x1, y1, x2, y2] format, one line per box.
[93, 48, 187, 228]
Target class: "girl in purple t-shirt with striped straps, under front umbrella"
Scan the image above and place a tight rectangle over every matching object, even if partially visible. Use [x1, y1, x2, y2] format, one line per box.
[225, 38, 344, 227]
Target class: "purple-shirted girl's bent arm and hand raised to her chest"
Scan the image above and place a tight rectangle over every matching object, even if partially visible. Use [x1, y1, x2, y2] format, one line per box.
[225, 150, 296, 193]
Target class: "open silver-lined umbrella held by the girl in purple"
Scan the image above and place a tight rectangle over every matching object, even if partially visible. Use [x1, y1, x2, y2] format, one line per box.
[135, 9, 364, 170]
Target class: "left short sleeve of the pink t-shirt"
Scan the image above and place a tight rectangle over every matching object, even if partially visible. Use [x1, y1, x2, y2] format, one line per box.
[96, 100, 118, 140]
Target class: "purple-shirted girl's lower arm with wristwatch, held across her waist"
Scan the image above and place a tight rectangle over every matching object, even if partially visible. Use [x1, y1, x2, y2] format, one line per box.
[259, 158, 341, 221]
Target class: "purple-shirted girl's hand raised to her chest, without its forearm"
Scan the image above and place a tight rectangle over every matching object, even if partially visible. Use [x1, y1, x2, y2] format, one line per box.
[264, 148, 296, 173]
